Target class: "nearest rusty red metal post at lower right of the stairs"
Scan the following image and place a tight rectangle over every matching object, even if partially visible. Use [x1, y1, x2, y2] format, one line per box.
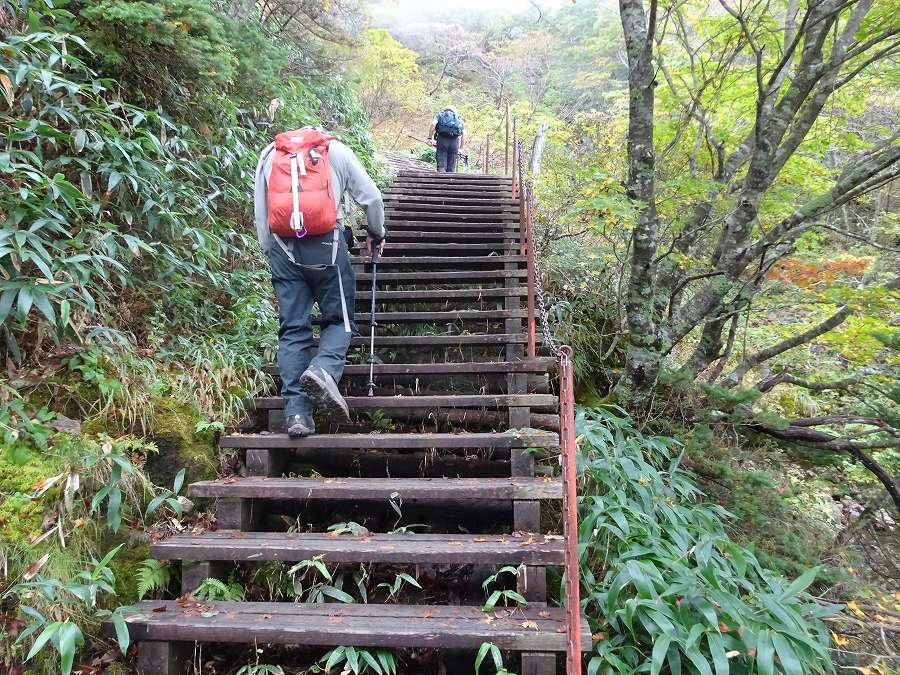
[559, 346, 581, 675]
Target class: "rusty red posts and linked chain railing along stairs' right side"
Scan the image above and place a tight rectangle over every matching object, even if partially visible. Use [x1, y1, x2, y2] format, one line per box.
[512, 119, 581, 675]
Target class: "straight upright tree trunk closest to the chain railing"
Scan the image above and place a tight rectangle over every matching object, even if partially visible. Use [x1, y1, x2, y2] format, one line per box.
[617, 0, 662, 408]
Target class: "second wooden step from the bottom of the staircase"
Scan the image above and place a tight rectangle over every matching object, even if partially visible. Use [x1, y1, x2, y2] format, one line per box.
[150, 530, 564, 565]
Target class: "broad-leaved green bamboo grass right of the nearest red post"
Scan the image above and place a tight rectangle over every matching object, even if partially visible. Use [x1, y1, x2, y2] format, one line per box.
[576, 408, 836, 675]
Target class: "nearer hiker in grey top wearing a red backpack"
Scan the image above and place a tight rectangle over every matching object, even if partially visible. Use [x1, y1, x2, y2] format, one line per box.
[255, 127, 386, 437]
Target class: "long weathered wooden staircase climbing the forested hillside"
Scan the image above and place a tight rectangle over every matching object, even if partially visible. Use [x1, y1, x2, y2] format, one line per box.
[107, 171, 590, 675]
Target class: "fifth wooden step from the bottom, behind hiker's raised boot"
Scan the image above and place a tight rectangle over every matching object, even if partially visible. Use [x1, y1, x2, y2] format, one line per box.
[253, 394, 559, 410]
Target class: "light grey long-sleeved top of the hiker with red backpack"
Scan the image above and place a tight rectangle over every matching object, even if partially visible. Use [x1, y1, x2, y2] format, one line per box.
[254, 141, 387, 253]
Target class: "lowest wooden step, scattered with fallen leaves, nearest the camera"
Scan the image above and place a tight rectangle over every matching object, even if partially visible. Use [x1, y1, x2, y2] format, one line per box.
[103, 600, 591, 652]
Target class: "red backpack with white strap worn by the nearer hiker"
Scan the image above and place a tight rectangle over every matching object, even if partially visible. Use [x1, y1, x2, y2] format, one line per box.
[268, 128, 337, 237]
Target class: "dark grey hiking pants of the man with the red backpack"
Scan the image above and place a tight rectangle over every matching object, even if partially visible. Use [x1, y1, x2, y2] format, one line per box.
[269, 231, 356, 417]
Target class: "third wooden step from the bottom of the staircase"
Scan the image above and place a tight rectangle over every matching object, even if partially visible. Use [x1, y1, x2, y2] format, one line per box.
[188, 477, 562, 502]
